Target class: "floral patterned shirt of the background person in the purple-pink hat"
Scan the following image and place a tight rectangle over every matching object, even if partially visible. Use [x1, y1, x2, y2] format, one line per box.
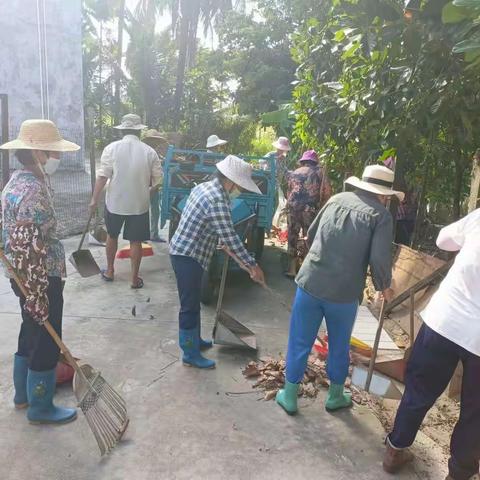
[287, 164, 332, 211]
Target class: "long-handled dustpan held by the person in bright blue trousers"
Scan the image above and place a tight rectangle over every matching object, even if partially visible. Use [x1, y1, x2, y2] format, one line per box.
[352, 300, 402, 400]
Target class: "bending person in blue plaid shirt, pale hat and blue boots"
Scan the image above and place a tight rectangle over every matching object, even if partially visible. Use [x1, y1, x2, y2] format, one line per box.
[170, 155, 264, 368]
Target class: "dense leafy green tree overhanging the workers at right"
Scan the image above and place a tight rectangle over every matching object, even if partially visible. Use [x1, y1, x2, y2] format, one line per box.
[293, 0, 480, 215]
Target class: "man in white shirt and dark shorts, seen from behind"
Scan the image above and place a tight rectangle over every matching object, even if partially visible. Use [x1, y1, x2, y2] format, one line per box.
[90, 114, 162, 288]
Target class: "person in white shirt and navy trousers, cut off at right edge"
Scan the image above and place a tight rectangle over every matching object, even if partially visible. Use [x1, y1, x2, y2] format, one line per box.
[383, 209, 480, 480]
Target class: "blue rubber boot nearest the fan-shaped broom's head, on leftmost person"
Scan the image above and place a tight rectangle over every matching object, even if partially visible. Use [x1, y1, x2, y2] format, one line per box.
[27, 369, 77, 424]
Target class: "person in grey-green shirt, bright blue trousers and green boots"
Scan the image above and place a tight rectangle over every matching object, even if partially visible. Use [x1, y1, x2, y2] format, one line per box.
[276, 165, 403, 414]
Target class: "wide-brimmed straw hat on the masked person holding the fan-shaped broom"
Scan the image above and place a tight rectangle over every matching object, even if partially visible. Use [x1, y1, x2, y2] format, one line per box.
[0, 120, 80, 152]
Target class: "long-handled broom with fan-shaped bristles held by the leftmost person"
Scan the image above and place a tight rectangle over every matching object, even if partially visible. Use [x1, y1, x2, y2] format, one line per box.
[0, 249, 129, 455]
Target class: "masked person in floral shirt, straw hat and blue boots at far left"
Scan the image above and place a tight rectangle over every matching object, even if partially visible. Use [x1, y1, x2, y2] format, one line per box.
[0, 120, 80, 423]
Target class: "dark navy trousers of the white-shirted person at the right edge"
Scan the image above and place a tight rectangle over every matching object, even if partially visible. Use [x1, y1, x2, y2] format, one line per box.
[389, 319, 480, 480]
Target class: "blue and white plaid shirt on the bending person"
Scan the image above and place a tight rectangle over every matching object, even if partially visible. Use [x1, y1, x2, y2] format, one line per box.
[170, 178, 255, 270]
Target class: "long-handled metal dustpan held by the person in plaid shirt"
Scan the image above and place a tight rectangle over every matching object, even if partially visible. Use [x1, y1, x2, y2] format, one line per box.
[212, 254, 257, 350]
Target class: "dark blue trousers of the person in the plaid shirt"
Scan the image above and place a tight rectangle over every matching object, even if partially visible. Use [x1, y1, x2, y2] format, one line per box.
[170, 255, 203, 330]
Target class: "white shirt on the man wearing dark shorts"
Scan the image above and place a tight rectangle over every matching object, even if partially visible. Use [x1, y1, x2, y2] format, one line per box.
[97, 135, 163, 215]
